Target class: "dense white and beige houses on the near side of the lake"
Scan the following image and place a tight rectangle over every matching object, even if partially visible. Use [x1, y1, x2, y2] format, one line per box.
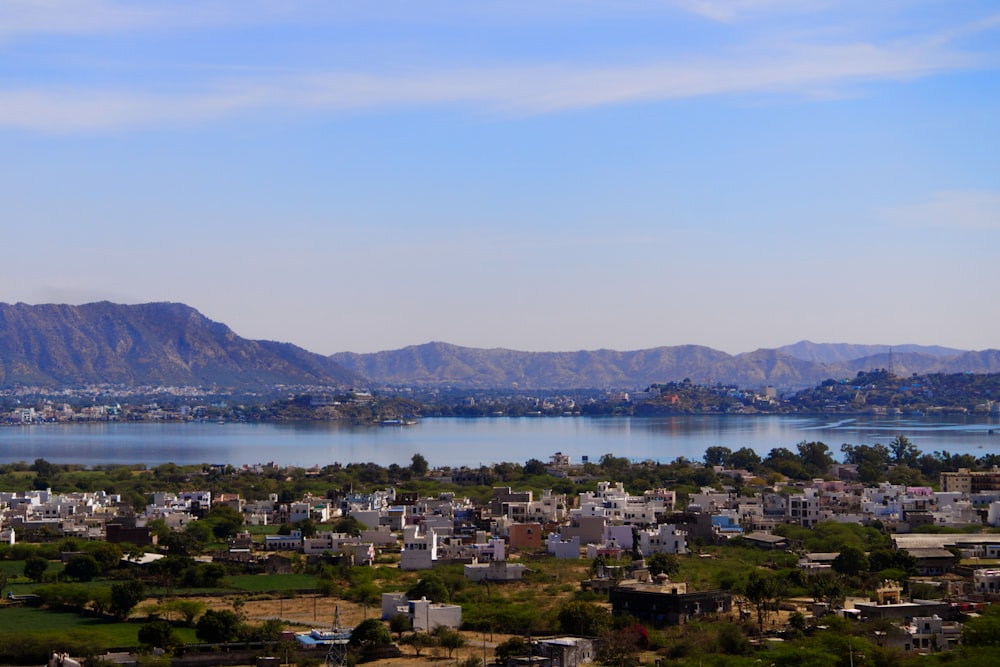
[0, 455, 1000, 650]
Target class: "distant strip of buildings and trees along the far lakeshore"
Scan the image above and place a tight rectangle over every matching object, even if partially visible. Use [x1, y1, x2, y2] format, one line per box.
[0, 369, 1000, 425]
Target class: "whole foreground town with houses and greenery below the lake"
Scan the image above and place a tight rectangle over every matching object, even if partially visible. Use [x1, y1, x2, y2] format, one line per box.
[0, 444, 1000, 667]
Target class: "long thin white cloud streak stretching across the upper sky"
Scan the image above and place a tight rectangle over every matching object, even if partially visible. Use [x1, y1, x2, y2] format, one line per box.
[0, 37, 990, 132]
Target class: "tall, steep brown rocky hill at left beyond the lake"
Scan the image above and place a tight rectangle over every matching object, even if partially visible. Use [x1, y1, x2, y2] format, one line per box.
[0, 302, 357, 388]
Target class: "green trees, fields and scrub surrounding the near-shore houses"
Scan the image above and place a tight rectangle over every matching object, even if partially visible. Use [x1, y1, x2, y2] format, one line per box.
[9, 448, 1000, 667]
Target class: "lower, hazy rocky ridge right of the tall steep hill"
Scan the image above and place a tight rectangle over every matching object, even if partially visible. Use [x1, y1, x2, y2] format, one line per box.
[331, 341, 1000, 389]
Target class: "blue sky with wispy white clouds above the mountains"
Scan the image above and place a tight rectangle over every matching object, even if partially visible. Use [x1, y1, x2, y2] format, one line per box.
[0, 0, 1000, 354]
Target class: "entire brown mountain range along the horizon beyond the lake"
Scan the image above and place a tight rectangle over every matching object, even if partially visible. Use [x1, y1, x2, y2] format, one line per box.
[0, 302, 1000, 389]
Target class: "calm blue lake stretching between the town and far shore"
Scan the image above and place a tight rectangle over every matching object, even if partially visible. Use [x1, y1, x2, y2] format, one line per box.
[0, 415, 1000, 467]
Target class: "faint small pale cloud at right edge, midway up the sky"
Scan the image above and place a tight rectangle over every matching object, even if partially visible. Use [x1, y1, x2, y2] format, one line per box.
[880, 190, 1000, 230]
